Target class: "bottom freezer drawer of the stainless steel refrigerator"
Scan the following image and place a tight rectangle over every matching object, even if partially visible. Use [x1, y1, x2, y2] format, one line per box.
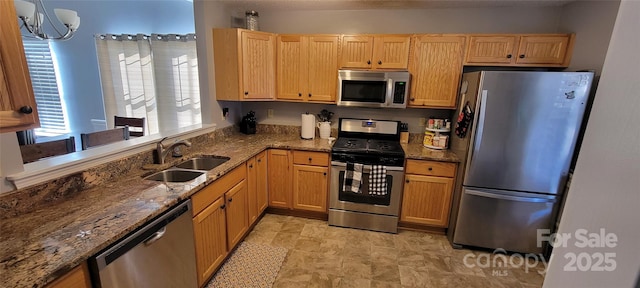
[453, 187, 557, 253]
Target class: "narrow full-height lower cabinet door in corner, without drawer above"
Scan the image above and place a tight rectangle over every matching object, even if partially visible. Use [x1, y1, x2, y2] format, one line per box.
[268, 149, 292, 208]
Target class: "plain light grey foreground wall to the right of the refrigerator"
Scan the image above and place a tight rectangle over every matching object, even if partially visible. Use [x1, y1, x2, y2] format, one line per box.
[544, 0, 640, 287]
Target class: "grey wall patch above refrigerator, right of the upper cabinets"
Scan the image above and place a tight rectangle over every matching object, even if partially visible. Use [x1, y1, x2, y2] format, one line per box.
[559, 1, 620, 75]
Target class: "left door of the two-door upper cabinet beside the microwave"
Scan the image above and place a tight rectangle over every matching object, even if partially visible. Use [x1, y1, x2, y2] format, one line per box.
[277, 35, 308, 101]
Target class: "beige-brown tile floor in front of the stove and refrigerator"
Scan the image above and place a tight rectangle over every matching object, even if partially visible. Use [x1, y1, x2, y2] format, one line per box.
[244, 214, 544, 288]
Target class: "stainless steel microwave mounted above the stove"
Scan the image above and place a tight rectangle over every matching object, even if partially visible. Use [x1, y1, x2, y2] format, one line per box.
[337, 70, 411, 108]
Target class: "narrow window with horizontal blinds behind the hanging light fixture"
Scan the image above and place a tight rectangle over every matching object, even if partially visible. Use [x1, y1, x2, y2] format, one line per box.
[23, 39, 69, 137]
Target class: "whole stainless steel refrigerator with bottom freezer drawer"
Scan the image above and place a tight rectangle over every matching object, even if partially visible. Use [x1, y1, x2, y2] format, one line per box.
[448, 71, 592, 253]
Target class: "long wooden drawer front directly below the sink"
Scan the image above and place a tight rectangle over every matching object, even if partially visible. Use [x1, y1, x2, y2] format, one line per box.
[191, 164, 247, 216]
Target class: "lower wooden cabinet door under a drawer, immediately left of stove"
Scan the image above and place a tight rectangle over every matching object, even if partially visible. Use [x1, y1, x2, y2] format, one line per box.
[293, 165, 329, 213]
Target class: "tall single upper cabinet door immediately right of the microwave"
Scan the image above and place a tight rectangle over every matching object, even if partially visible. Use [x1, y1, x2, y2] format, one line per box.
[408, 35, 465, 108]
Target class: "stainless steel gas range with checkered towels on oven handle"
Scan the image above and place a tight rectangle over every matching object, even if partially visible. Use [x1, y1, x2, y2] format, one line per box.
[329, 118, 404, 233]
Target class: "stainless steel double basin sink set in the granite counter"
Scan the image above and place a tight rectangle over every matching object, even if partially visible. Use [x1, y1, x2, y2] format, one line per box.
[144, 155, 230, 182]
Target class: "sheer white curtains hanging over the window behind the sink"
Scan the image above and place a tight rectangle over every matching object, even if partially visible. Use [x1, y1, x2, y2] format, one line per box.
[96, 34, 202, 134]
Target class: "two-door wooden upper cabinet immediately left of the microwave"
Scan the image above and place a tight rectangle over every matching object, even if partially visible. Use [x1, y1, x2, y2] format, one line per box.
[277, 35, 339, 103]
